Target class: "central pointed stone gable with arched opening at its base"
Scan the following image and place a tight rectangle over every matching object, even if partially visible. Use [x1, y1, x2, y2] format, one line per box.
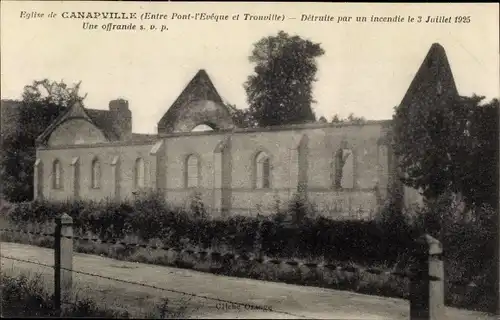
[158, 69, 232, 133]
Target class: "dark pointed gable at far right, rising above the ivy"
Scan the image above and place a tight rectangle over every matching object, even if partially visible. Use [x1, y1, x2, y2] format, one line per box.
[401, 43, 458, 106]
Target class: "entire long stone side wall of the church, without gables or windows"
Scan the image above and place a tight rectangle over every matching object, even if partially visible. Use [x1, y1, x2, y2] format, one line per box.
[38, 123, 390, 218]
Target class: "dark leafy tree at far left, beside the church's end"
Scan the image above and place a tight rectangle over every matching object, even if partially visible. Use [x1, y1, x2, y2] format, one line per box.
[0, 79, 83, 202]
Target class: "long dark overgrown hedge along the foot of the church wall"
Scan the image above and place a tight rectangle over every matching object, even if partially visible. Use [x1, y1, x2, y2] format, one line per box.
[2, 194, 496, 284]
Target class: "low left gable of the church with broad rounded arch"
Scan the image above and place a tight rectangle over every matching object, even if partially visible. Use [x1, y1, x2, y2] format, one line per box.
[36, 101, 112, 145]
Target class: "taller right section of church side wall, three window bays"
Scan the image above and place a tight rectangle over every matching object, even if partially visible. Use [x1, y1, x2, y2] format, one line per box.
[156, 124, 388, 215]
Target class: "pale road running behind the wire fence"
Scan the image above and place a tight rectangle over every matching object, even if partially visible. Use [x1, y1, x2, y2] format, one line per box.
[0, 243, 495, 320]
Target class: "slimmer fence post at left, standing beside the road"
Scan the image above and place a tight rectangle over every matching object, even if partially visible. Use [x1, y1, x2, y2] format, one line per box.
[54, 213, 73, 312]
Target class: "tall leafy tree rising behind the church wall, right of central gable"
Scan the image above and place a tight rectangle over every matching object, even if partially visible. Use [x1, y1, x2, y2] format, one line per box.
[244, 31, 324, 126]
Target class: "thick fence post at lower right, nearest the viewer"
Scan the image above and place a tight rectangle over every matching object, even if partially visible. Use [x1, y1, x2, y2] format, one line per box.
[410, 234, 445, 320]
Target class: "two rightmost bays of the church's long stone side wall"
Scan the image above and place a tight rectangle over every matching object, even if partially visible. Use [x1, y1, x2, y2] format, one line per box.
[227, 124, 387, 216]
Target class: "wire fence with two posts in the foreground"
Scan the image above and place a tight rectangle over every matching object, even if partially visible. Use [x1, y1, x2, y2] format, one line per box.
[2, 214, 445, 320]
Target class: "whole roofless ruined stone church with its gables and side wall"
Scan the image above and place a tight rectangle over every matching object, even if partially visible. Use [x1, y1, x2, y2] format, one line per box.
[34, 44, 458, 218]
